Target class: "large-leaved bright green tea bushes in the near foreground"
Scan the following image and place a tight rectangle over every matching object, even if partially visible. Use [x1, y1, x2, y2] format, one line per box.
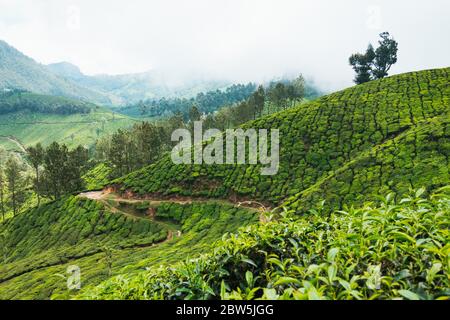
[81, 188, 450, 300]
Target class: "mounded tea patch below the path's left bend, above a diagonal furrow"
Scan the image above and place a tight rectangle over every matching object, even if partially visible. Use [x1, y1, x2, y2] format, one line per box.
[1, 196, 167, 264]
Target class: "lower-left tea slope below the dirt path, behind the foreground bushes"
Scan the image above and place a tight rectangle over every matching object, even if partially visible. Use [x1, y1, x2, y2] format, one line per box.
[0, 196, 258, 299]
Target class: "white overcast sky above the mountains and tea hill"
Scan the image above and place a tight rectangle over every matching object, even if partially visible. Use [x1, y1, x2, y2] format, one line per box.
[0, 0, 450, 90]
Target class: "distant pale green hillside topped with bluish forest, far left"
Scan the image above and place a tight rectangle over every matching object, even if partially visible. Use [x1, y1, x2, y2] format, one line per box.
[0, 91, 135, 151]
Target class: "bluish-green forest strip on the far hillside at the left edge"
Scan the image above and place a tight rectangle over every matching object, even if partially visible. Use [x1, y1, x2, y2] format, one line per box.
[0, 89, 93, 115]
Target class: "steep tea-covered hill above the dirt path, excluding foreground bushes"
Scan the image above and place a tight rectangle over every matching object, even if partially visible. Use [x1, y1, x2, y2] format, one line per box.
[115, 68, 450, 210]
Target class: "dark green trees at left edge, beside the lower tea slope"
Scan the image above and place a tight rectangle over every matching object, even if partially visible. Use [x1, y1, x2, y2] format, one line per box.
[0, 142, 90, 219]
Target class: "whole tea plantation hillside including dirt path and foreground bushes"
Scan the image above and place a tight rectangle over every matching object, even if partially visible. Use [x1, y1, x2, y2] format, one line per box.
[0, 68, 450, 299]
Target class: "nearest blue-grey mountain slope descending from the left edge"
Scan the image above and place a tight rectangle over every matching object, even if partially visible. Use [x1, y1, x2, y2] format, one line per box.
[0, 40, 111, 104]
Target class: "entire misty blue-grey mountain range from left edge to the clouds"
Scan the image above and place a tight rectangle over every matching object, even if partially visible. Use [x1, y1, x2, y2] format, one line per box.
[0, 40, 229, 105]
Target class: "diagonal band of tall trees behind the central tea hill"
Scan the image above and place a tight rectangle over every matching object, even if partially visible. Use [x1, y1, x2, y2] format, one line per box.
[95, 76, 305, 177]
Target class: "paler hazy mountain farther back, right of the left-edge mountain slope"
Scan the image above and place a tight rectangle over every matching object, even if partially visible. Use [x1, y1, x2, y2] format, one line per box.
[47, 62, 229, 105]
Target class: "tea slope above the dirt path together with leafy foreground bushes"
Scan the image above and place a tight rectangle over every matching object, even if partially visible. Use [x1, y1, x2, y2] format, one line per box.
[79, 68, 450, 300]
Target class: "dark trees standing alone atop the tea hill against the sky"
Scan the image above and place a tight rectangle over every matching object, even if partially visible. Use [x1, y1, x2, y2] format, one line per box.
[349, 32, 398, 84]
